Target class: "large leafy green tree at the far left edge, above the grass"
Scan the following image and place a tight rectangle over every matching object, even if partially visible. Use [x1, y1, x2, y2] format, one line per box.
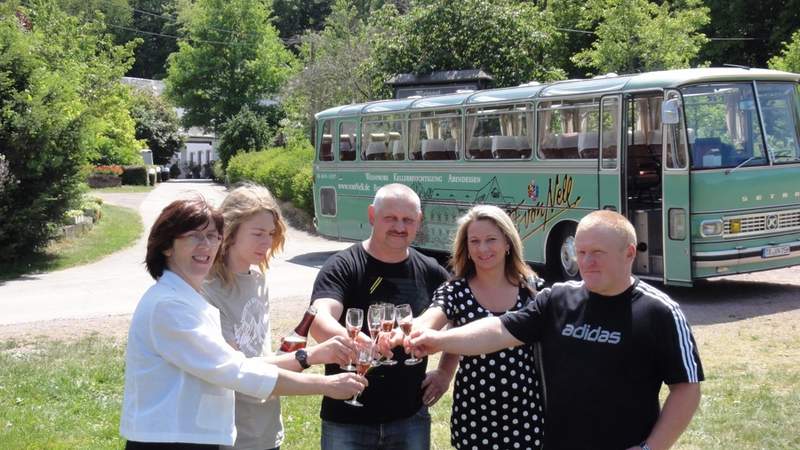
[0, 0, 136, 261]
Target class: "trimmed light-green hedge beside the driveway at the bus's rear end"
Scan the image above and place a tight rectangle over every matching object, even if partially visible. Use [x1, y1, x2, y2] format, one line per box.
[226, 143, 314, 214]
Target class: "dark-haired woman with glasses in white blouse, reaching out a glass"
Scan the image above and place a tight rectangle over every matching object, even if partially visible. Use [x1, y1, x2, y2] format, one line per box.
[120, 199, 366, 449]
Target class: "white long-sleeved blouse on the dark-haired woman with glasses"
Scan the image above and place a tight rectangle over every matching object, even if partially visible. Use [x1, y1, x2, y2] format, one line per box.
[120, 270, 278, 445]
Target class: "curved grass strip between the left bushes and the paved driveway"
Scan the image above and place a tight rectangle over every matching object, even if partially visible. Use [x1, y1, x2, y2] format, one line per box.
[0, 204, 143, 280]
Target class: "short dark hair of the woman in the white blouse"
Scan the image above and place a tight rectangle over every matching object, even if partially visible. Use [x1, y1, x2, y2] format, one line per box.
[144, 197, 224, 280]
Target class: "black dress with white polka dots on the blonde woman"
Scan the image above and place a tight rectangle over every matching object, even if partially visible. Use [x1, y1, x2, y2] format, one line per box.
[433, 279, 544, 450]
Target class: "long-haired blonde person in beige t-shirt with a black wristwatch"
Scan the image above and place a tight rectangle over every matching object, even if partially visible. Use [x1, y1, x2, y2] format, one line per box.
[203, 184, 353, 450]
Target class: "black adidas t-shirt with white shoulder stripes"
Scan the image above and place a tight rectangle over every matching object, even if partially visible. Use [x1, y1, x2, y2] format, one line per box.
[501, 279, 703, 450]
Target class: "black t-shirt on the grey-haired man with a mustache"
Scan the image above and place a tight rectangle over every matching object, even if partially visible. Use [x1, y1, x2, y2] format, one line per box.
[311, 243, 448, 424]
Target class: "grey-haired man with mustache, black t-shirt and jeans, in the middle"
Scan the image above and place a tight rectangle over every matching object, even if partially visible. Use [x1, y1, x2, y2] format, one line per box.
[311, 184, 450, 450]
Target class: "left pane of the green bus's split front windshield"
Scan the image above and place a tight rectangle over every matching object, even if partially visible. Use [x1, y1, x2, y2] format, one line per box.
[682, 83, 769, 169]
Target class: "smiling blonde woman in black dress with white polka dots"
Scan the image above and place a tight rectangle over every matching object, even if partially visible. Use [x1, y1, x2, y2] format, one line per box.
[414, 205, 544, 450]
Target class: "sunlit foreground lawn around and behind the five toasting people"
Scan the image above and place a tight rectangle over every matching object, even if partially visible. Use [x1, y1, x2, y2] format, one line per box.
[0, 314, 800, 450]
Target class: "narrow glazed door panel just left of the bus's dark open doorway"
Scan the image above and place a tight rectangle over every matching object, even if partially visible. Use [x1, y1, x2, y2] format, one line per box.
[597, 95, 623, 214]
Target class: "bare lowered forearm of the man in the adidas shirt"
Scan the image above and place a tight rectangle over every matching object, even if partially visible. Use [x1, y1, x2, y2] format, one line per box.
[632, 383, 700, 450]
